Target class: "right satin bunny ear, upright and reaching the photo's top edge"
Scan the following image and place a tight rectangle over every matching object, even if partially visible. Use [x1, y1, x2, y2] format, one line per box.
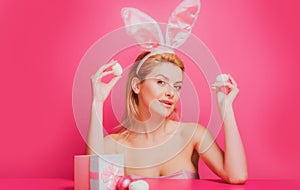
[166, 0, 200, 48]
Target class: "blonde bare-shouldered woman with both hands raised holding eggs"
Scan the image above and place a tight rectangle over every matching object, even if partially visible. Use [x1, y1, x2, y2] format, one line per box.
[87, 52, 247, 184]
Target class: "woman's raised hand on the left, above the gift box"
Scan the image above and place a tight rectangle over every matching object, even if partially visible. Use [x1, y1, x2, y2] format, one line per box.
[91, 60, 121, 102]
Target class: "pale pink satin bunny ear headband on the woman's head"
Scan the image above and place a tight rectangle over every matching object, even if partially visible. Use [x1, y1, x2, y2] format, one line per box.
[121, 0, 200, 74]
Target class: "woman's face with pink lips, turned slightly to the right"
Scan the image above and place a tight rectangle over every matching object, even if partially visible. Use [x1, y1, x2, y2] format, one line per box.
[138, 62, 183, 118]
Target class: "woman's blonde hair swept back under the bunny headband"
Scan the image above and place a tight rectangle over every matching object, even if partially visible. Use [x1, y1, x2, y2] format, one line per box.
[119, 52, 184, 128]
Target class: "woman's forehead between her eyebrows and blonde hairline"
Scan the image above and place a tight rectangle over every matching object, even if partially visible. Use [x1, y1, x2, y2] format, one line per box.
[148, 62, 183, 81]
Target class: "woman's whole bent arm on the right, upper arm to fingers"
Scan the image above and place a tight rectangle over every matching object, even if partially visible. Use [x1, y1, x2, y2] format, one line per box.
[198, 75, 248, 184]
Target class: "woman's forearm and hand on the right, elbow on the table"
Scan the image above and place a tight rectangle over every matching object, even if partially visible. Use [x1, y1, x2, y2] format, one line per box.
[213, 75, 248, 183]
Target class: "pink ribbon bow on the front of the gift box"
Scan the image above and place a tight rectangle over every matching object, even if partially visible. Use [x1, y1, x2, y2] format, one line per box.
[101, 164, 122, 190]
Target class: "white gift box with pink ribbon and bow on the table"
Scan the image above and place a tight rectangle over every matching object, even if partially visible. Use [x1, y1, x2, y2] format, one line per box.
[89, 154, 124, 190]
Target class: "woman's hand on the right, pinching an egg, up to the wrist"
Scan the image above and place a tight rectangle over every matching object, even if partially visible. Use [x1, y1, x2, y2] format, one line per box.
[212, 74, 239, 111]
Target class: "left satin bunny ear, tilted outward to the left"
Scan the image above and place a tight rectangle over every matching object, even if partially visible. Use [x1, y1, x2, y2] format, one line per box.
[121, 8, 164, 51]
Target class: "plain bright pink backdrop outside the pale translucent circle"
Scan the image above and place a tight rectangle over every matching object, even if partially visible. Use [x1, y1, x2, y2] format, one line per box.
[0, 0, 300, 179]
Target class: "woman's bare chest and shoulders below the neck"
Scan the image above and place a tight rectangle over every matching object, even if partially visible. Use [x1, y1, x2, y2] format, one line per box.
[104, 121, 198, 177]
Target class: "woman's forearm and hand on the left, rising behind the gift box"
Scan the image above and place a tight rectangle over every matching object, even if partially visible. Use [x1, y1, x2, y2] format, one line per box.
[86, 60, 121, 154]
